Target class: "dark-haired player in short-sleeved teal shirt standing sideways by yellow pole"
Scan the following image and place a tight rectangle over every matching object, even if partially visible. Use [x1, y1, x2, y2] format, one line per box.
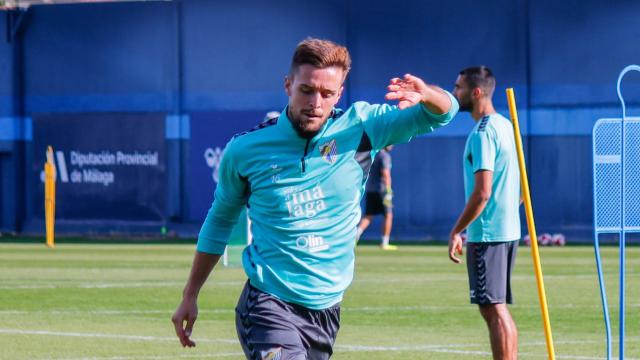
[449, 66, 520, 360]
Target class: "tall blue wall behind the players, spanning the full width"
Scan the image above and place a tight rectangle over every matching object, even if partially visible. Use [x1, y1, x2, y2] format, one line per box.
[0, 0, 640, 239]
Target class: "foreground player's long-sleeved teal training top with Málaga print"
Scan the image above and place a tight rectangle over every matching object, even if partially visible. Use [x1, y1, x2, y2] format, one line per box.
[197, 94, 458, 309]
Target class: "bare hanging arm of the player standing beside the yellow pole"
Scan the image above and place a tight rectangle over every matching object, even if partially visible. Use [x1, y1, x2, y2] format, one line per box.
[449, 170, 493, 263]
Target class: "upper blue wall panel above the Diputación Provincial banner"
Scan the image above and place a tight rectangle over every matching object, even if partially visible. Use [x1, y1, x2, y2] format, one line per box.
[23, 2, 177, 113]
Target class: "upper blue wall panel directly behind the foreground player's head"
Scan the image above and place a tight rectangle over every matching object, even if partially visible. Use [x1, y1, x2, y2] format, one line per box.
[181, 0, 348, 111]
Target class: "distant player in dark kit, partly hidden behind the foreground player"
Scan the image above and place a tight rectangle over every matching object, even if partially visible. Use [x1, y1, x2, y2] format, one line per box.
[357, 145, 398, 250]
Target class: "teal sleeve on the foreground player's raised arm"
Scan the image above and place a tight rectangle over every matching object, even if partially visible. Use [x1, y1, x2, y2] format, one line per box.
[354, 92, 459, 150]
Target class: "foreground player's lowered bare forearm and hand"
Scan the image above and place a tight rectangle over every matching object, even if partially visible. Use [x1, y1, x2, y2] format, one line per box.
[171, 251, 220, 347]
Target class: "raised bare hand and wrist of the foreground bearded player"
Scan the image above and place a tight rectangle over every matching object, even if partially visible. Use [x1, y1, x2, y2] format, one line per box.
[385, 74, 452, 114]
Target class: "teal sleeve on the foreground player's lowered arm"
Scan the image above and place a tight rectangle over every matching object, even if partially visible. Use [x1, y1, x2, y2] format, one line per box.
[197, 140, 248, 254]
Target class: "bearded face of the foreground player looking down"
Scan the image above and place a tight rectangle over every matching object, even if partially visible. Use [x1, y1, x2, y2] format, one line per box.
[284, 64, 344, 138]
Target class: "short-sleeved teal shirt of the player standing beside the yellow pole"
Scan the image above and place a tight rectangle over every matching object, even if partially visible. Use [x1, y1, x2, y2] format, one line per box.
[462, 114, 520, 242]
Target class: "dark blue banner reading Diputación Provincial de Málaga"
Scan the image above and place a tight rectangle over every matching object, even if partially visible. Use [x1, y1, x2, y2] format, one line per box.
[30, 114, 167, 221]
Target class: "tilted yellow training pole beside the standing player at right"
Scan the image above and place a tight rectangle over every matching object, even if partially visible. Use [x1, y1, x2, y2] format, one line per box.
[507, 88, 556, 360]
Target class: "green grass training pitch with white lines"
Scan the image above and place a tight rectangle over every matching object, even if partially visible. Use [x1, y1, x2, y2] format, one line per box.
[0, 243, 640, 360]
